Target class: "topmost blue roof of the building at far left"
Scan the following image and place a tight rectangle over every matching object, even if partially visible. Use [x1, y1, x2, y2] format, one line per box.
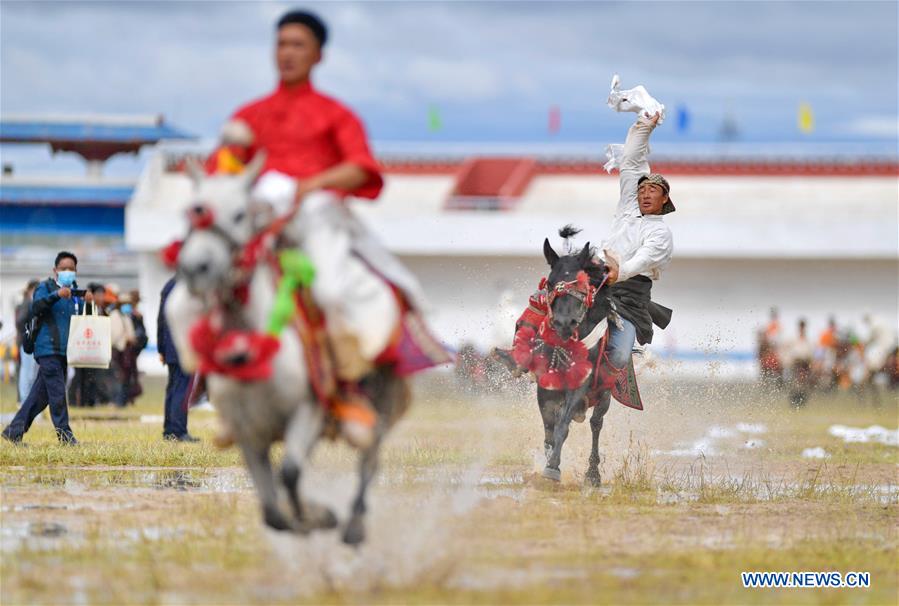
[0, 120, 194, 143]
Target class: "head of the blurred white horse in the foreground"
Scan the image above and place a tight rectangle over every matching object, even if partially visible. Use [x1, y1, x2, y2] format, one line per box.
[178, 153, 265, 300]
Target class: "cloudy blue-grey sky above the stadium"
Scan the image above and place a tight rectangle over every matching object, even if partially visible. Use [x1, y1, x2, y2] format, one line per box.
[0, 0, 899, 173]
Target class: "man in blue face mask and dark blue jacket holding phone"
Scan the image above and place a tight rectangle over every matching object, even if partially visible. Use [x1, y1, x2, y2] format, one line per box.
[2, 251, 93, 445]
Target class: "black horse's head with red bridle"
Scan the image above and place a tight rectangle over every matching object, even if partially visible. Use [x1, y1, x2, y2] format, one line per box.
[543, 238, 611, 339]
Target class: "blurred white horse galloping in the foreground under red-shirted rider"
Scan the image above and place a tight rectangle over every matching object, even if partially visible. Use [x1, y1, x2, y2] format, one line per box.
[165, 154, 409, 544]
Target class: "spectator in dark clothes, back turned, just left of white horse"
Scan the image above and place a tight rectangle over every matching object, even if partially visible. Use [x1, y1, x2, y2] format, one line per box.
[156, 278, 199, 442]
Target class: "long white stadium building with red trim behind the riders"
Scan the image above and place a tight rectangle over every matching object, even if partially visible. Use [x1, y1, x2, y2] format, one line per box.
[125, 145, 899, 374]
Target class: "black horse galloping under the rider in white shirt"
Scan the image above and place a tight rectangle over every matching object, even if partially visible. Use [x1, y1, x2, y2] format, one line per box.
[537, 235, 612, 486]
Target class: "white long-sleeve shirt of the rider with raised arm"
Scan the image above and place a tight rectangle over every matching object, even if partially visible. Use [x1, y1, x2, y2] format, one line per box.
[602, 117, 674, 282]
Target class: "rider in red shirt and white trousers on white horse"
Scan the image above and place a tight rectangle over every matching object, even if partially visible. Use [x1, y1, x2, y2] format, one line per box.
[207, 11, 449, 447]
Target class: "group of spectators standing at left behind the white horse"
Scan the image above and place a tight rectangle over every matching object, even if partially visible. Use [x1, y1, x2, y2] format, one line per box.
[0, 251, 203, 444]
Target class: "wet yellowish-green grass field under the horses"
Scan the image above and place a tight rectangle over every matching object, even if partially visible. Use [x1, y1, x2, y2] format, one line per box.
[0, 382, 899, 604]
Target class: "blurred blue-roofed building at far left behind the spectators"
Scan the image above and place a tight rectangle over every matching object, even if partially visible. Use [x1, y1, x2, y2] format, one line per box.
[0, 115, 190, 334]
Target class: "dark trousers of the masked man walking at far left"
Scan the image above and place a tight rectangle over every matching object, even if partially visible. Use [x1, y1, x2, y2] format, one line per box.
[3, 356, 74, 442]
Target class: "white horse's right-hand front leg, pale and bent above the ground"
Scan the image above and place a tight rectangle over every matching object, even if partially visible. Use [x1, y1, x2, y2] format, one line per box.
[281, 402, 337, 534]
